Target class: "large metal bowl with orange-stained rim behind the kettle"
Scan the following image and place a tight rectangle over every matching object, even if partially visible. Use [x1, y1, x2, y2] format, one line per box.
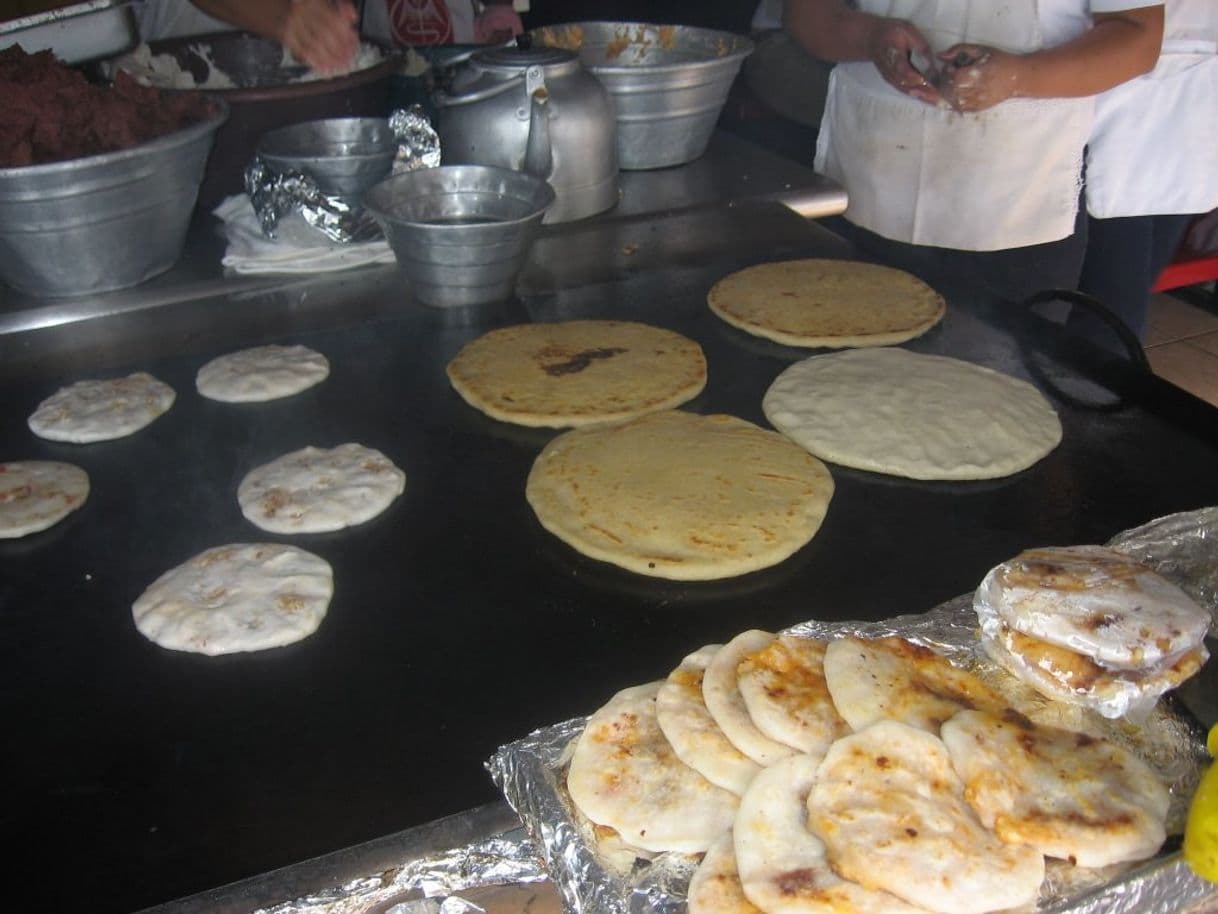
[529, 22, 753, 171]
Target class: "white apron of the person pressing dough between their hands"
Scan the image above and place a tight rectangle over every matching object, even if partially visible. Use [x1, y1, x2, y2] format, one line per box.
[816, 0, 1094, 251]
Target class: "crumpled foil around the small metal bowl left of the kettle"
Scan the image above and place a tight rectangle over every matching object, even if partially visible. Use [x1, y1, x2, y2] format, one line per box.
[245, 105, 440, 244]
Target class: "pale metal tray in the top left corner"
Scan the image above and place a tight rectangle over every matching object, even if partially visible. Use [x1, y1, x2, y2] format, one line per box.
[0, 0, 140, 63]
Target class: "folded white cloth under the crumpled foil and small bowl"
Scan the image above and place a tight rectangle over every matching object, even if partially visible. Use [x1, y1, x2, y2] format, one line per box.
[212, 194, 393, 273]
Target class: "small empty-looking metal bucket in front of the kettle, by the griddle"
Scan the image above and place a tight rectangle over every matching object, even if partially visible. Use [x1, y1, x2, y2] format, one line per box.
[364, 165, 554, 307]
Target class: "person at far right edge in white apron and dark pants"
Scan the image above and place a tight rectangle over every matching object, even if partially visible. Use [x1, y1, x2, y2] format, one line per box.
[1069, 0, 1218, 340]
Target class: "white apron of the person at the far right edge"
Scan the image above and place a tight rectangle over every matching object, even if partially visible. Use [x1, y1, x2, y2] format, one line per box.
[1086, 0, 1218, 219]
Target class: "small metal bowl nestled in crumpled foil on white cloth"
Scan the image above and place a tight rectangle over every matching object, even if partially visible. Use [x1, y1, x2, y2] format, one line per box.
[258, 117, 397, 201]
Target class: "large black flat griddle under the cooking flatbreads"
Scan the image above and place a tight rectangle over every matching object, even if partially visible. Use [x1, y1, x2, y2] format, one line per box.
[0, 135, 1218, 912]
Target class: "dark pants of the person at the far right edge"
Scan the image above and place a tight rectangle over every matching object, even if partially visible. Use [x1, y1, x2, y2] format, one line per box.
[1068, 214, 1194, 340]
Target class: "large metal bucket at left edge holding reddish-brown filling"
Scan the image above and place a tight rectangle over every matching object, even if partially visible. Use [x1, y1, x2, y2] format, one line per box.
[0, 102, 228, 296]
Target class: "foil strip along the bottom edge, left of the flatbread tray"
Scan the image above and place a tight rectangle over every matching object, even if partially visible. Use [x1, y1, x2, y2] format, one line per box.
[253, 830, 546, 914]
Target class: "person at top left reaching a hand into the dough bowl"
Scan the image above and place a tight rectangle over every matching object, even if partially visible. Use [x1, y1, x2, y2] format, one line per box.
[136, 0, 359, 73]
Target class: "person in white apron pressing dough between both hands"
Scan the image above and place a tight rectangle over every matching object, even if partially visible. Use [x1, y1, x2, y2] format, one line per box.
[784, 0, 1162, 299]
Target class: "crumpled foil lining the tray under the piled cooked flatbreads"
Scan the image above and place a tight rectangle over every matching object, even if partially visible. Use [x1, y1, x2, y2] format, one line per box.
[487, 508, 1218, 914]
